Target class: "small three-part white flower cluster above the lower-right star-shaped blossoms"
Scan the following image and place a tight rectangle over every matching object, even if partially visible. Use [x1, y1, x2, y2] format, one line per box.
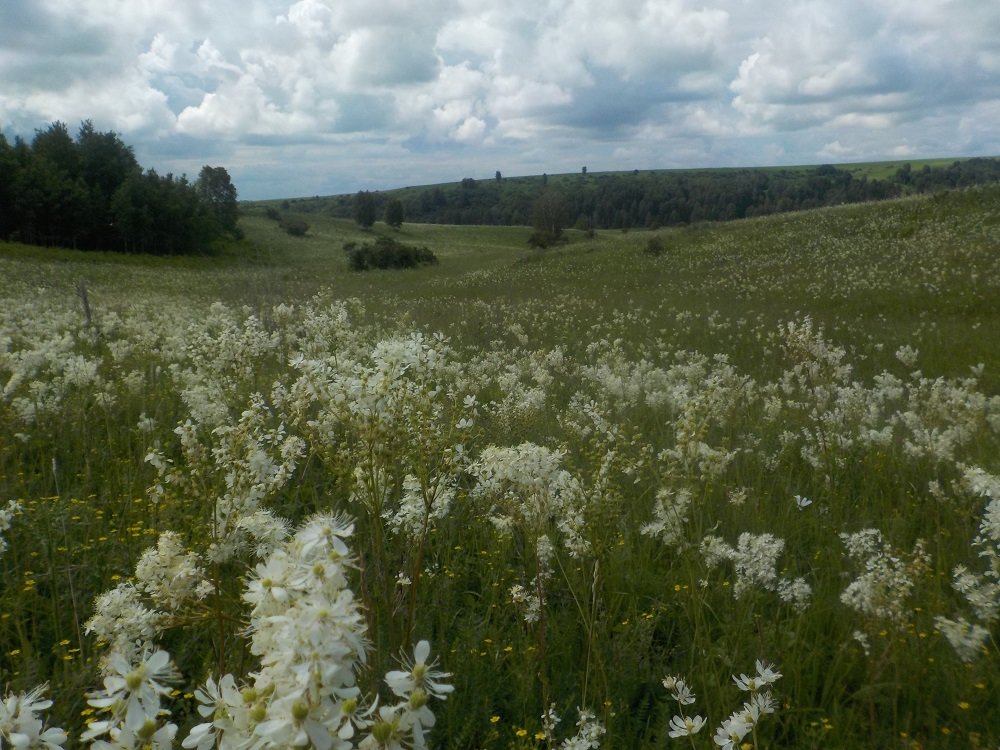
[701, 531, 812, 612]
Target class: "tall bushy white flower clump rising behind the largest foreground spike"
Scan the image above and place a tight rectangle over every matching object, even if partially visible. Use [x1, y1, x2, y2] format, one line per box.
[281, 333, 468, 540]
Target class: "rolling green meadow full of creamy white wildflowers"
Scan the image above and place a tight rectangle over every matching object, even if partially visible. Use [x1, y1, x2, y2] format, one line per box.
[0, 187, 1000, 750]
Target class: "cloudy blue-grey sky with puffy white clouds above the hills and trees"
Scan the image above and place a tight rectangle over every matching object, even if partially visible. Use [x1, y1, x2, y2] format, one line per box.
[0, 0, 1000, 199]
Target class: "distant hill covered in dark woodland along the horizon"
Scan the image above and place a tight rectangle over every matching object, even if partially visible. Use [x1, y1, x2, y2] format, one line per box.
[260, 158, 1000, 229]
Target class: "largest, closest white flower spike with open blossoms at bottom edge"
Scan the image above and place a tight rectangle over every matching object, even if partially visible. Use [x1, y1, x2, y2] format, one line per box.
[182, 514, 453, 750]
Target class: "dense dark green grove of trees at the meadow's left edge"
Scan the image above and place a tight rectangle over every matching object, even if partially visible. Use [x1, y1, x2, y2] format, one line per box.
[0, 120, 238, 255]
